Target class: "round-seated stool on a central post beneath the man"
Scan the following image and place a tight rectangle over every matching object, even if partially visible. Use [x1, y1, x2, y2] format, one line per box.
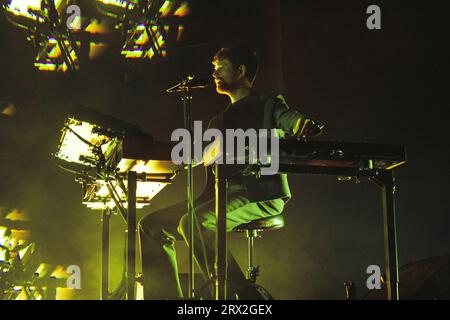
[233, 214, 284, 286]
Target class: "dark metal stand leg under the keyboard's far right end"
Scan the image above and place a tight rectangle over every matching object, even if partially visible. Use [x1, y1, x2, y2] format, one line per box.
[370, 170, 399, 300]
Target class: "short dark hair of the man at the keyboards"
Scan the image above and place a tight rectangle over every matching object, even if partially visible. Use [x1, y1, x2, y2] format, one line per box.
[214, 46, 258, 82]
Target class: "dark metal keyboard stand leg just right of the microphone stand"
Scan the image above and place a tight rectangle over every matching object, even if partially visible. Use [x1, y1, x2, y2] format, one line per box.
[214, 164, 227, 300]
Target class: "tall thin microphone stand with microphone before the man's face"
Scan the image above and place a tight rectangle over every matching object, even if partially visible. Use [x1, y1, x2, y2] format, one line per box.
[166, 76, 206, 299]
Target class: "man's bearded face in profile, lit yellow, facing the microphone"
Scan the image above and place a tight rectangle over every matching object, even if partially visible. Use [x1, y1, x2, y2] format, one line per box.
[213, 59, 239, 94]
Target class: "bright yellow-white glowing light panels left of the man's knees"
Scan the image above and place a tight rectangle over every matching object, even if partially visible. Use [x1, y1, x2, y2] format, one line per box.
[55, 117, 176, 209]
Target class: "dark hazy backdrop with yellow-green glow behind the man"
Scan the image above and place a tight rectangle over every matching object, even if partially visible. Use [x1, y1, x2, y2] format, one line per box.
[0, 0, 450, 299]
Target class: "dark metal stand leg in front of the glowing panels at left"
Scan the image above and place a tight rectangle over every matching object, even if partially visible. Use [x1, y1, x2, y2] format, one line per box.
[126, 171, 137, 300]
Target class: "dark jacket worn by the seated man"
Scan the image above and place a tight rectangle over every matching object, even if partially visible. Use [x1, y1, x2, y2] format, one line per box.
[200, 92, 302, 202]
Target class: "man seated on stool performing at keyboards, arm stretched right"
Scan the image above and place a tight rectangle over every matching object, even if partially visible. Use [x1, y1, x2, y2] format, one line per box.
[139, 47, 323, 299]
